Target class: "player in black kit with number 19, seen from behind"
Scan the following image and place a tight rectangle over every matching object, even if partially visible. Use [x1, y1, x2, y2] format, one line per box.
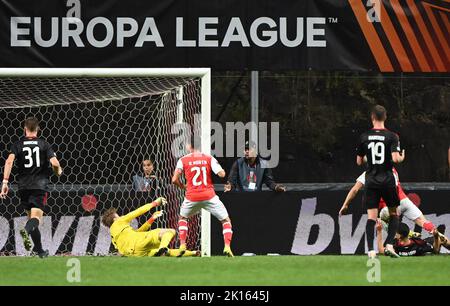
[356, 105, 405, 258]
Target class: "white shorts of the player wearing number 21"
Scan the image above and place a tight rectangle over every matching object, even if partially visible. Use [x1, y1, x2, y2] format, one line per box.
[180, 196, 228, 221]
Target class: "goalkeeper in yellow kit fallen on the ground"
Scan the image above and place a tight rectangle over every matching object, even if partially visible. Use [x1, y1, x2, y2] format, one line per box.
[102, 198, 200, 257]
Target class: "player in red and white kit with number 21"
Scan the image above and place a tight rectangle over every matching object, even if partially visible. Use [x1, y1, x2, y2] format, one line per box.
[172, 139, 233, 257]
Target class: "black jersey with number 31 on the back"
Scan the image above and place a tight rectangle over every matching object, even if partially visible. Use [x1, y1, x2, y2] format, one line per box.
[10, 137, 56, 191]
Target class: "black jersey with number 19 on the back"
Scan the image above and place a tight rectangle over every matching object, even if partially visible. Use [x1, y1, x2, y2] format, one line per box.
[357, 129, 400, 188]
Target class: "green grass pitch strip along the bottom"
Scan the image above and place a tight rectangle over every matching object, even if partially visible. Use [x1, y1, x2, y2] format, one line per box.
[0, 255, 450, 286]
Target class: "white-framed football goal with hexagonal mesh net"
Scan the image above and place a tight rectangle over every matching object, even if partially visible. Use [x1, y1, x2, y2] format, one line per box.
[0, 69, 210, 255]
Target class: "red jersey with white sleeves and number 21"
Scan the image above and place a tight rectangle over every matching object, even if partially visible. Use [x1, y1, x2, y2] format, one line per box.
[176, 152, 222, 202]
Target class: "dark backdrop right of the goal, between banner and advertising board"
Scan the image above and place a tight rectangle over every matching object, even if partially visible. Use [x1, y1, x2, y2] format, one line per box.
[212, 71, 450, 183]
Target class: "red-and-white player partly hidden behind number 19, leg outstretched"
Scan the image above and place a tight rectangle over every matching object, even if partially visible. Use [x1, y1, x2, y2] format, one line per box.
[339, 168, 435, 234]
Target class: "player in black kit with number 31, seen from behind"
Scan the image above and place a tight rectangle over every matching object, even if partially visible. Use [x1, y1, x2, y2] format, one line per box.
[0, 117, 62, 258]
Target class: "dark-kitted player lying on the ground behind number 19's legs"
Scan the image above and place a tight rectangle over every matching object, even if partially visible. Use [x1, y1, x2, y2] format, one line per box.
[376, 220, 450, 256]
